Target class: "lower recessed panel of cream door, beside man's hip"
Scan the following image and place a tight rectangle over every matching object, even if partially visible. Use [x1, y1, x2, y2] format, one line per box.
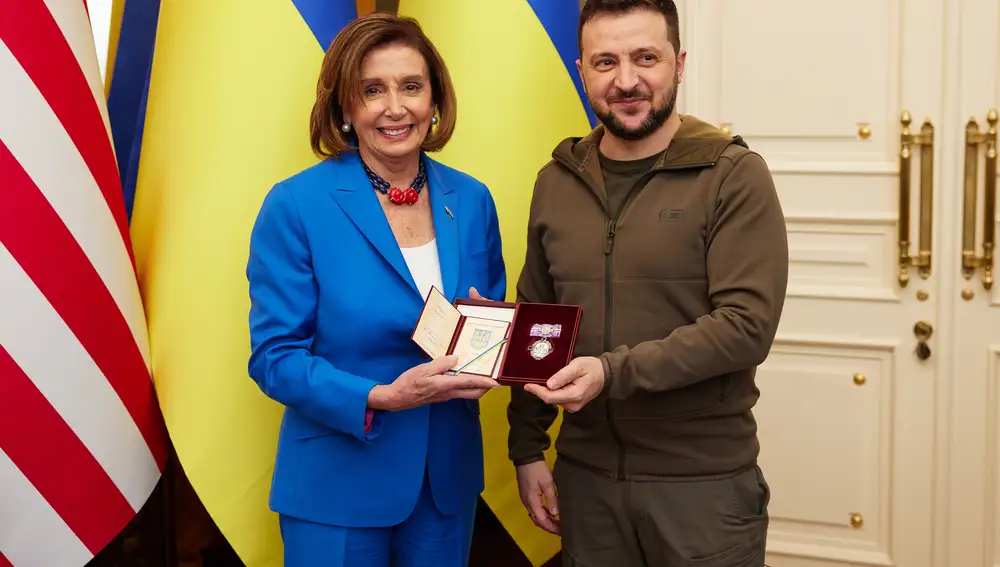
[756, 333, 901, 566]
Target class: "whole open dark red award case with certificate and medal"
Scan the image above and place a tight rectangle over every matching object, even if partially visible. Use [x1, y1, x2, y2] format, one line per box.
[413, 288, 583, 386]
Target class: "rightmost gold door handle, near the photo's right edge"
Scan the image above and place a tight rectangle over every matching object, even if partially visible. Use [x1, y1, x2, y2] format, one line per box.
[962, 109, 998, 289]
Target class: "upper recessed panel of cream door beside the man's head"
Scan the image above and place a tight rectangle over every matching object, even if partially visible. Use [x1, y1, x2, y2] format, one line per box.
[679, 0, 904, 176]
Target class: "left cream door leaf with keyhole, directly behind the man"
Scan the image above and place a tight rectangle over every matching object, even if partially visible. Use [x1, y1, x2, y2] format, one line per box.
[679, 0, 948, 567]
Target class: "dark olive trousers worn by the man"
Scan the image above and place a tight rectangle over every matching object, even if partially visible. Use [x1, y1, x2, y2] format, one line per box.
[553, 459, 770, 567]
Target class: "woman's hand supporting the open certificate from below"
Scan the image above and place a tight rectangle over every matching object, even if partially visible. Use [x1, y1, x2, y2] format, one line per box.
[368, 356, 500, 411]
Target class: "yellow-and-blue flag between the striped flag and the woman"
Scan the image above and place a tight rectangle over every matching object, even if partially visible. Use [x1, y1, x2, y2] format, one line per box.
[121, 0, 371, 567]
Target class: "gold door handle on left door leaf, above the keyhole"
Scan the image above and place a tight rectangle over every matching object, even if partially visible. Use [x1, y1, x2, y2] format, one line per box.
[899, 110, 934, 287]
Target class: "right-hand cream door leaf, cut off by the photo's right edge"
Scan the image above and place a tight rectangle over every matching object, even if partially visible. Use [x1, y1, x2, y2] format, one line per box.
[938, 0, 1000, 567]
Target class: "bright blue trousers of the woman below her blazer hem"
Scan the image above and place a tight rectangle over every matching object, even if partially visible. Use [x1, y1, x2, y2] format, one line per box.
[279, 473, 478, 567]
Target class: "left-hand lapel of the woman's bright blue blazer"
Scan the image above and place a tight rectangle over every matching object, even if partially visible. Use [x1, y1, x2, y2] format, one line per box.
[330, 152, 420, 295]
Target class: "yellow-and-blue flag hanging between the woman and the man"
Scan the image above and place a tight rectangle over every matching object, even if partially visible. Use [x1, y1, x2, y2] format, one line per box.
[390, 0, 596, 565]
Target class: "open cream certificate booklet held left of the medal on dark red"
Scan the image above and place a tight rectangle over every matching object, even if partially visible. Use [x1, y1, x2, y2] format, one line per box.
[412, 288, 514, 378]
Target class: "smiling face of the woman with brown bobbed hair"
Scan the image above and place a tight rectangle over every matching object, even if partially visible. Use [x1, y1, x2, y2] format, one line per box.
[344, 44, 434, 163]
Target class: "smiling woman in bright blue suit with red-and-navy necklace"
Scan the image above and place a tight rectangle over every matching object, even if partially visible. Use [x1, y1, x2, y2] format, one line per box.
[247, 14, 506, 567]
